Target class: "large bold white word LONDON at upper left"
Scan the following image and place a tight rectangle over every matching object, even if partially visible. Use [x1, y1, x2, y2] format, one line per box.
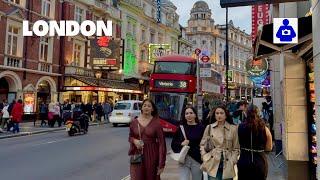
[22, 20, 112, 36]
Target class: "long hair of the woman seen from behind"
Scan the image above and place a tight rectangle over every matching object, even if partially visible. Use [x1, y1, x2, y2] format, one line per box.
[244, 104, 265, 134]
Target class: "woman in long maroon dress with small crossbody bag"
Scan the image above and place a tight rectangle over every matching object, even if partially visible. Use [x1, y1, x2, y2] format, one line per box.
[129, 99, 167, 180]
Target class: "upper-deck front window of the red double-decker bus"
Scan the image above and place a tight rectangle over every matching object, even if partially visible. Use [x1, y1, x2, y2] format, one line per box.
[154, 61, 195, 75]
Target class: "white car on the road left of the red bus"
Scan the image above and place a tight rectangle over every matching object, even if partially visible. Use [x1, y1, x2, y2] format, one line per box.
[109, 100, 142, 127]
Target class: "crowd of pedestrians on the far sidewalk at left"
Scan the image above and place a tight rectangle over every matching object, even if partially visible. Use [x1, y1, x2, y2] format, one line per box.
[0, 99, 113, 133]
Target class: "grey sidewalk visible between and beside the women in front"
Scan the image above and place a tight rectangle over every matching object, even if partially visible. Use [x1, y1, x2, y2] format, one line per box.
[161, 152, 287, 180]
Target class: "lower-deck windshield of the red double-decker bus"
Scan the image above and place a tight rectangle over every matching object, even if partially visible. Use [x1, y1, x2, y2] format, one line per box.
[152, 93, 186, 121]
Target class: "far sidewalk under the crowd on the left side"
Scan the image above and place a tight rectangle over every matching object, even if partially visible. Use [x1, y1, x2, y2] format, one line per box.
[0, 122, 105, 139]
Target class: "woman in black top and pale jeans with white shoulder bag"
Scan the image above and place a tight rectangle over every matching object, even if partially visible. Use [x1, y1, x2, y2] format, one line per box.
[171, 107, 205, 180]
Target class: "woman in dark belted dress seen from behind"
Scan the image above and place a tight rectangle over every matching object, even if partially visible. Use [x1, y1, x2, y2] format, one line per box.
[237, 105, 272, 180]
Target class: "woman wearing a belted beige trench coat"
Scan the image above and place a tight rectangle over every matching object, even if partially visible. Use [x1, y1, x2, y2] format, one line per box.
[200, 106, 239, 180]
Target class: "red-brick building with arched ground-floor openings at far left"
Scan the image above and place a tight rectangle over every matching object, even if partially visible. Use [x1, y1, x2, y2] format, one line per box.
[0, 0, 61, 111]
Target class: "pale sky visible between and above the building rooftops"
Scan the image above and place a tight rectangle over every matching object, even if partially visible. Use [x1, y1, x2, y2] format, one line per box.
[170, 0, 251, 34]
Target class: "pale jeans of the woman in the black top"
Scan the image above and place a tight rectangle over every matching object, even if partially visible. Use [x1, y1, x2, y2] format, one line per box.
[179, 155, 202, 180]
